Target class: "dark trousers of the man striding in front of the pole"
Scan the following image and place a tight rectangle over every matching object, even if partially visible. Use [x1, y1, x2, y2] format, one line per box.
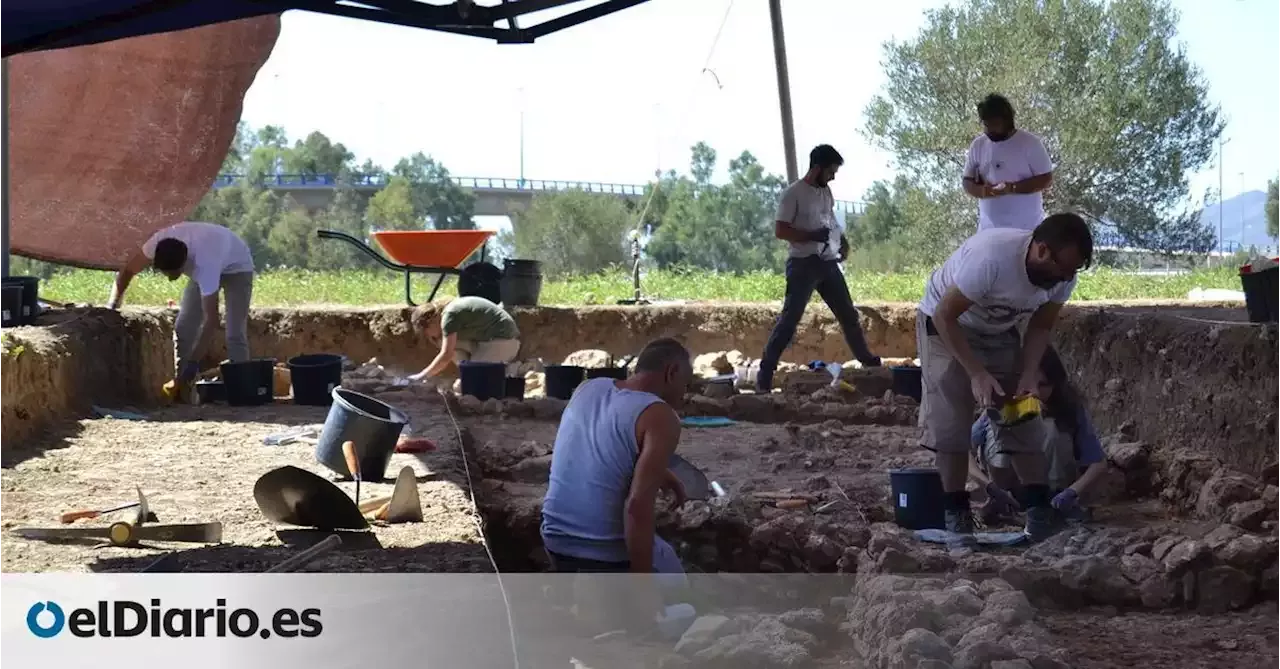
[756, 256, 876, 386]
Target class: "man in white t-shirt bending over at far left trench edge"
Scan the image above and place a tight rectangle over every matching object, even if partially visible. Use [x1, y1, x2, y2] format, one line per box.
[110, 221, 253, 385]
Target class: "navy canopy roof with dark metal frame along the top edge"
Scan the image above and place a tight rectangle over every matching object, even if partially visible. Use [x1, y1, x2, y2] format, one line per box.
[0, 0, 646, 58]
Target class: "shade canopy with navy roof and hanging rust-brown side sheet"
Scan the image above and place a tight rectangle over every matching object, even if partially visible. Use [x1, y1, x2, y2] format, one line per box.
[0, 0, 646, 275]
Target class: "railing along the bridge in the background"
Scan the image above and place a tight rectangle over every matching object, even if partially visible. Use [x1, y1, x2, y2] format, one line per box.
[214, 174, 867, 215]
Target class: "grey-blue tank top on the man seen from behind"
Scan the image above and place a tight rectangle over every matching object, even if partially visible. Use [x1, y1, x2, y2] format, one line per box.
[541, 379, 662, 562]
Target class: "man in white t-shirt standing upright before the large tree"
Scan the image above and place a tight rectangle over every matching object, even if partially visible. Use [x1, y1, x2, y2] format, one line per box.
[964, 93, 1053, 230]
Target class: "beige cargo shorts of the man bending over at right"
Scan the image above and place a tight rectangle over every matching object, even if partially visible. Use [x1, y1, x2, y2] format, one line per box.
[915, 311, 1044, 453]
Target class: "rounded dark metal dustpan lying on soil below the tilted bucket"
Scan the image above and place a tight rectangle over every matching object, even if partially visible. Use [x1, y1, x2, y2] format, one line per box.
[253, 464, 369, 530]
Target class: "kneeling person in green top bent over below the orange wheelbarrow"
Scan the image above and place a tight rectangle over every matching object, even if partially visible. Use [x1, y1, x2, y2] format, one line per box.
[410, 295, 520, 381]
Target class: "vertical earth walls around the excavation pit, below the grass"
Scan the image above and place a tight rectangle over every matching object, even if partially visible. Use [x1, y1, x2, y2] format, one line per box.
[0, 302, 1280, 471]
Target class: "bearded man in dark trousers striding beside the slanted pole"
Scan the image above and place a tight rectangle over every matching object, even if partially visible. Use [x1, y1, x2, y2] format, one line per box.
[755, 145, 881, 393]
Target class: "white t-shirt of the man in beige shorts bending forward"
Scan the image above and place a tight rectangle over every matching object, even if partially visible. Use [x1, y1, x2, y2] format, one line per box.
[920, 228, 1076, 334]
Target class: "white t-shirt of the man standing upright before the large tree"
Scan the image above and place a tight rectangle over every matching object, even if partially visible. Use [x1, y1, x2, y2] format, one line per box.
[964, 130, 1053, 230]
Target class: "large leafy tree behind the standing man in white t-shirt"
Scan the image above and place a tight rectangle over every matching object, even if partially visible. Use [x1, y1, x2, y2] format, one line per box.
[865, 0, 1224, 251]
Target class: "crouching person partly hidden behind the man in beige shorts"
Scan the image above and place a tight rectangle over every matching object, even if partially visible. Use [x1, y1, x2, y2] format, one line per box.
[969, 348, 1107, 524]
